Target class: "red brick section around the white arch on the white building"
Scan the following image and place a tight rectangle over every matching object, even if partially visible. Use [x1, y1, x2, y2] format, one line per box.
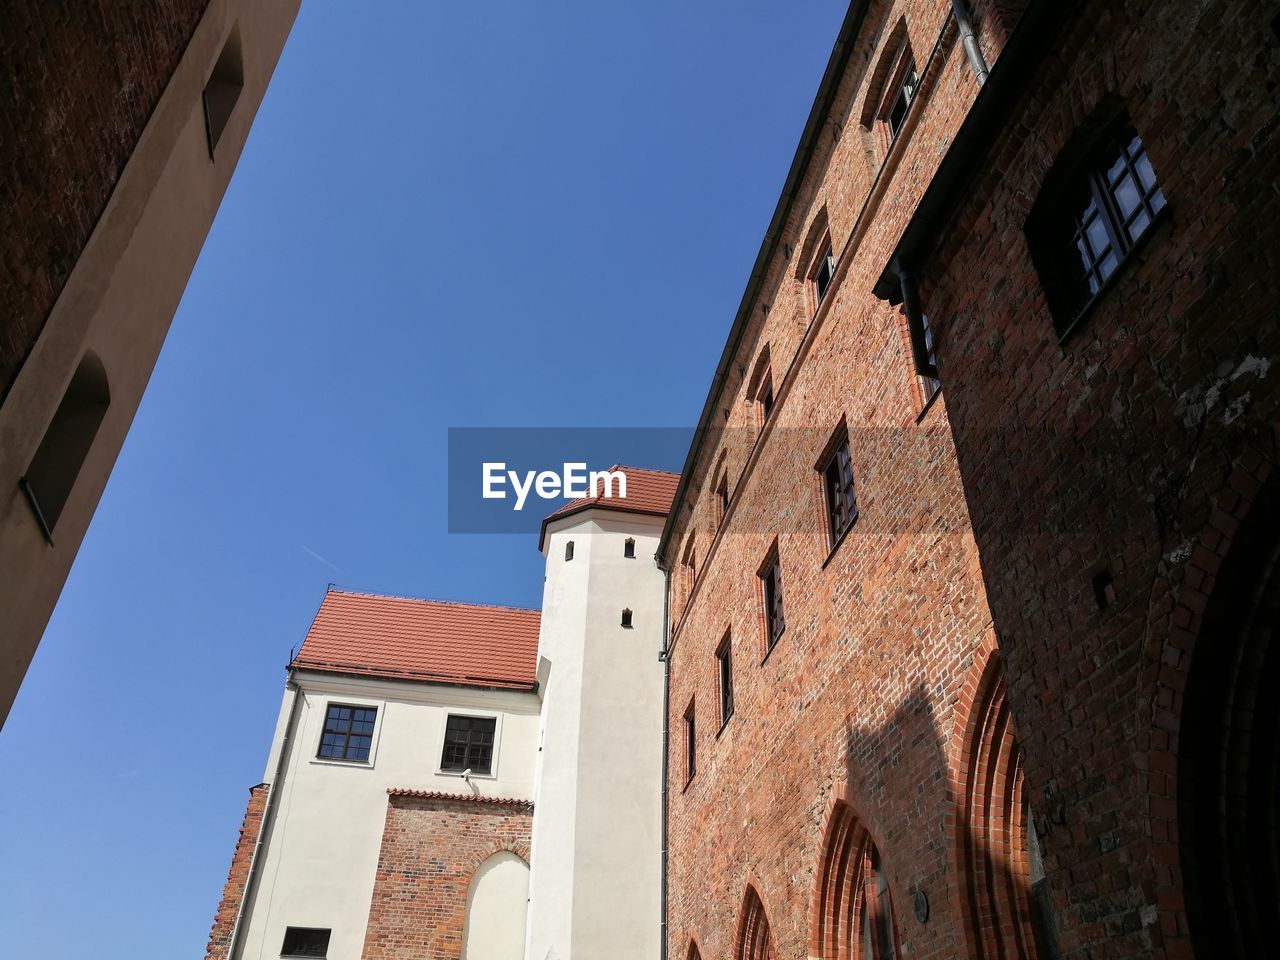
[362, 794, 532, 960]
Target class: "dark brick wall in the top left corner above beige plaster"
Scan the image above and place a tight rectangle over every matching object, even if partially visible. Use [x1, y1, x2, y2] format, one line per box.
[0, 0, 209, 399]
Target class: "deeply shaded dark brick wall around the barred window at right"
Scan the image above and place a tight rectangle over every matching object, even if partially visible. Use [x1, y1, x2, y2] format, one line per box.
[919, 0, 1280, 960]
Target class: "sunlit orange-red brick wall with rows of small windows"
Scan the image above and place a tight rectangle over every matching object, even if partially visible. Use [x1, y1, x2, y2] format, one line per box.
[667, 0, 993, 960]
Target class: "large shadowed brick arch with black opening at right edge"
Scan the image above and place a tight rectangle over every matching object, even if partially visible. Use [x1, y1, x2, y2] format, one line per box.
[1144, 434, 1280, 957]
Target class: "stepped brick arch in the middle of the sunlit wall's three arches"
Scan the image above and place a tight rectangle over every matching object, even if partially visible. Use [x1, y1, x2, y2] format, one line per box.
[809, 791, 897, 960]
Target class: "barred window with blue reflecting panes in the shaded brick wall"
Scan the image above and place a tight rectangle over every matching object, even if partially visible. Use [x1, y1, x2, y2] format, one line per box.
[1059, 129, 1165, 321]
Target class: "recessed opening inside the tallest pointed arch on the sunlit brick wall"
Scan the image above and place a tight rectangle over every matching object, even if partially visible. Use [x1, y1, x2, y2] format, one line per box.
[959, 653, 1056, 960]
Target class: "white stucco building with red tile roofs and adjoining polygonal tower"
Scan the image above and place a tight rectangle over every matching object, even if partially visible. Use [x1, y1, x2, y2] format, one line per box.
[207, 468, 677, 960]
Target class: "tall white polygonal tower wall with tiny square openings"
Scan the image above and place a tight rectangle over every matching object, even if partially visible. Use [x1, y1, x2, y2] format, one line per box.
[527, 509, 664, 960]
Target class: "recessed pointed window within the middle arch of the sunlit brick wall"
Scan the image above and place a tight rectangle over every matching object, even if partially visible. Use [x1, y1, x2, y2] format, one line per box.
[810, 801, 899, 960]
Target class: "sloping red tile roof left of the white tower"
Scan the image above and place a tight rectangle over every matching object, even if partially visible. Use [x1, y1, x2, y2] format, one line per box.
[292, 590, 541, 690]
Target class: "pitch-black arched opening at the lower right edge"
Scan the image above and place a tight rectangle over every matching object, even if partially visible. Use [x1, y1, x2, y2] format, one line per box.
[1178, 480, 1280, 960]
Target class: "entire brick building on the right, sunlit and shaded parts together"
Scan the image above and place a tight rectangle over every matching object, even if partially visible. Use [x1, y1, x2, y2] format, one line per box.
[660, 0, 1280, 960]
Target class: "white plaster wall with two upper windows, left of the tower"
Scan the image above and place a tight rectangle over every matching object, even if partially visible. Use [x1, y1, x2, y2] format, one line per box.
[241, 672, 539, 960]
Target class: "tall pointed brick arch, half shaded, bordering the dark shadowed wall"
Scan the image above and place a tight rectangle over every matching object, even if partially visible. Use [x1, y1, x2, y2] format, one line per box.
[950, 647, 1037, 960]
